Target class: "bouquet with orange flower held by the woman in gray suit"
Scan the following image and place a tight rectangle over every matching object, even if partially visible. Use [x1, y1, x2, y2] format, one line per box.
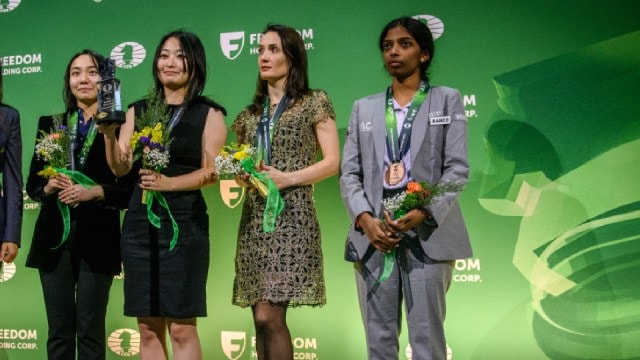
[382, 181, 464, 219]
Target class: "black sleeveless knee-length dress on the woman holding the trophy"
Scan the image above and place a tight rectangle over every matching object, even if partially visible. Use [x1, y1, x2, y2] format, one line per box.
[121, 98, 224, 318]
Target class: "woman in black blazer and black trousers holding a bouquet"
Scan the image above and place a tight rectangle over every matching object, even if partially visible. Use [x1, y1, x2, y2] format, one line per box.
[27, 50, 133, 359]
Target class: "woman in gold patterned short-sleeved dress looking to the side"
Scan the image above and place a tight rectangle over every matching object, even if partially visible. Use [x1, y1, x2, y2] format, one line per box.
[232, 25, 340, 360]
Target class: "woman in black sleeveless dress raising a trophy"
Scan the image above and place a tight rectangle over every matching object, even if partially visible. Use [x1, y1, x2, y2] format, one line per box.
[103, 31, 227, 360]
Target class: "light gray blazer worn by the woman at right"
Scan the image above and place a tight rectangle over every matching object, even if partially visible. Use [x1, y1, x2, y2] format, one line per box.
[340, 87, 472, 261]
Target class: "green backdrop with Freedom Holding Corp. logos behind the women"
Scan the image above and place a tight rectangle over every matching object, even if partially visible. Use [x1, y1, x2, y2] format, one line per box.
[0, 0, 640, 360]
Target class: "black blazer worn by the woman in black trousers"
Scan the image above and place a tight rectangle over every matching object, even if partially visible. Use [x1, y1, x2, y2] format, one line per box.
[26, 114, 137, 275]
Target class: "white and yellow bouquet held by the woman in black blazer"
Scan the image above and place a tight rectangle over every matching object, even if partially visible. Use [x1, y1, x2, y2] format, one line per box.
[35, 115, 71, 178]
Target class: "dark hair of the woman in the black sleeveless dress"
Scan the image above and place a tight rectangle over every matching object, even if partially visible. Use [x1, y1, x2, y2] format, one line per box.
[152, 29, 207, 103]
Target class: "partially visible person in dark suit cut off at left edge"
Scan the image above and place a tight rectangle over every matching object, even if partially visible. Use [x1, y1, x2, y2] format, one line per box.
[0, 64, 22, 264]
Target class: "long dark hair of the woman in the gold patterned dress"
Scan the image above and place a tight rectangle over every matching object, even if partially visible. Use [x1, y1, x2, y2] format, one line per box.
[249, 24, 309, 114]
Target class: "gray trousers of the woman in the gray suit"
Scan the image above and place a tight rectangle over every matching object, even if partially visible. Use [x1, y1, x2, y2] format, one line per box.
[355, 239, 453, 360]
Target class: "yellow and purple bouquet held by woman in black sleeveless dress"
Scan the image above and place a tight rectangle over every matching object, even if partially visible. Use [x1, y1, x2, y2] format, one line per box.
[130, 90, 171, 171]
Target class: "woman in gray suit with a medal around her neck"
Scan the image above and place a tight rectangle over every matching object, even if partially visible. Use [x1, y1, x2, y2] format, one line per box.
[340, 17, 471, 360]
